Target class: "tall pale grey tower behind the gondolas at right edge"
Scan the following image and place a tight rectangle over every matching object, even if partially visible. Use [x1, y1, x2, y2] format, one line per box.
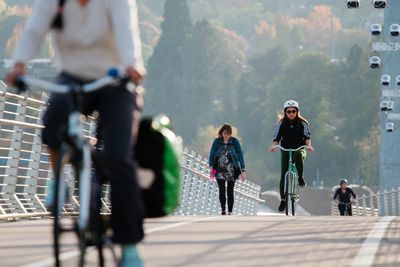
[372, 0, 400, 190]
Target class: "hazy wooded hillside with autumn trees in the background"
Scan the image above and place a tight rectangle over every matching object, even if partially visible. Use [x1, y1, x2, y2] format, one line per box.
[0, 0, 382, 192]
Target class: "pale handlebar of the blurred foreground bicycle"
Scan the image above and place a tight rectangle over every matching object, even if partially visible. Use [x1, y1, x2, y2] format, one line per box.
[16, 69, 129, 93]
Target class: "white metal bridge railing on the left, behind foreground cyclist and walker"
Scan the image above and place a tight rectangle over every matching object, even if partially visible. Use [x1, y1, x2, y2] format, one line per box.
[0, 85, 263, 219]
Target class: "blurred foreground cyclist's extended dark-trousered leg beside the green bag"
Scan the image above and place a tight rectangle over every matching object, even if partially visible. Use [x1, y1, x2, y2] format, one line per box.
[98, 88, 144, 247]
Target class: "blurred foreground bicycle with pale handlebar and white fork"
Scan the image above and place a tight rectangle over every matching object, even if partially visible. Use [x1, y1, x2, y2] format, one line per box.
[17, 70, 128, 267]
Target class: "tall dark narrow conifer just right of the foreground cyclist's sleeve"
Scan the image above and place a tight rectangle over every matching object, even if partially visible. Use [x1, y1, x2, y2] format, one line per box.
[145, 0, 192, 118]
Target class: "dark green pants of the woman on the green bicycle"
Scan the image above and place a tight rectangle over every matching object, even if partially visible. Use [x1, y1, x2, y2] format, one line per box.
[279, 149, 307, 199]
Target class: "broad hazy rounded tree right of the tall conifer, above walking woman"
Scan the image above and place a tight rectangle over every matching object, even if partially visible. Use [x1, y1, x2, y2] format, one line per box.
[177, 20, 243, 137]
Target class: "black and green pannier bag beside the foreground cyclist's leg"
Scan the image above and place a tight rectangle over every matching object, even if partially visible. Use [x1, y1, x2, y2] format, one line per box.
[134, 115, 182, 218]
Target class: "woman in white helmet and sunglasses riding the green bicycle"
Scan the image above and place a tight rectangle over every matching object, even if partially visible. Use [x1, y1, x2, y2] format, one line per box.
[269, 100, 314, 214]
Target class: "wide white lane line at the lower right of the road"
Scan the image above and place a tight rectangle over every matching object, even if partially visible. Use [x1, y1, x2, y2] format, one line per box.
[351, 216, 396, 267]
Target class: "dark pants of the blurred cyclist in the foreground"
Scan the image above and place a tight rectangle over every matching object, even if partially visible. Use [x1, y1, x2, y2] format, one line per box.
[42, 74, 144, 244]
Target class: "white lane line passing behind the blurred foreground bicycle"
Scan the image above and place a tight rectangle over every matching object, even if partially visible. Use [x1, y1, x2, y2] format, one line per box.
[21, 216, 222, 267]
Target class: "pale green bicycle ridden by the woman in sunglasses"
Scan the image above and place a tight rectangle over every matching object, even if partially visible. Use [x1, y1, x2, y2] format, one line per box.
[275, 145, 307, 216]
